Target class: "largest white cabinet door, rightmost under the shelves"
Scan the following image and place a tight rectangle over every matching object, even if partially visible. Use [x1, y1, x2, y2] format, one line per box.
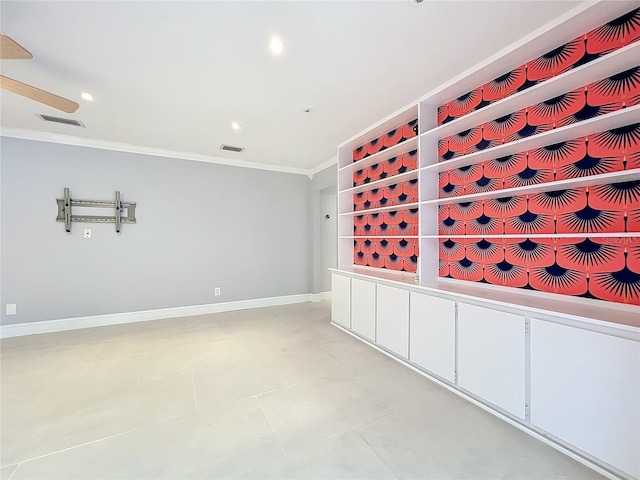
[530, 319, 640, 478]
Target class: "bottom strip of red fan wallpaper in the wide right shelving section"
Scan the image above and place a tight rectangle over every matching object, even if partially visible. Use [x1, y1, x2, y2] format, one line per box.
[439, 234, 640, 305]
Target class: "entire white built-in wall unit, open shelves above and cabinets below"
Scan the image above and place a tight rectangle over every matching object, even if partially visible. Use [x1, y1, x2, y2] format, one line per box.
[332, 2, 640, 479]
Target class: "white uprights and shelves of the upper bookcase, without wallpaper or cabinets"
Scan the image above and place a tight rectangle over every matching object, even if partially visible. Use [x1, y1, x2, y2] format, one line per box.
[338, 1, 640, 290]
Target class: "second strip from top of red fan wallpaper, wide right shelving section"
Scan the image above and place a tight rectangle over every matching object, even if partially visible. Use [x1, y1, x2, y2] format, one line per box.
[438, 66, 640, 161]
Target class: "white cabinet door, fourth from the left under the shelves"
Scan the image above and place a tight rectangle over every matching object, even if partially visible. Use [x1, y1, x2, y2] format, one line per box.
[409, 292, 456, 383]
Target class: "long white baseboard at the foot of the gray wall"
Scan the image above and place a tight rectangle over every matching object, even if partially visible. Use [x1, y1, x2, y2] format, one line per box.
[0, 292, 316, 338]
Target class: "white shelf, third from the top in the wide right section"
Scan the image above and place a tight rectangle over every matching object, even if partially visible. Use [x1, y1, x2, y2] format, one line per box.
[420, 168, 640, 205]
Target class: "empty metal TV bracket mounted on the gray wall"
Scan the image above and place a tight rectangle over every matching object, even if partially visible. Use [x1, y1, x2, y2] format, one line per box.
[56, 188, 136, 233]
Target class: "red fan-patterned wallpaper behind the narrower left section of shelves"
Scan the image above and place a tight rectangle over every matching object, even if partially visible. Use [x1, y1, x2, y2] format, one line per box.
[353, 120, 419, 272]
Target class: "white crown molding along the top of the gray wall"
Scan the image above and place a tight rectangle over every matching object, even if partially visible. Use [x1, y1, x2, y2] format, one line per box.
[0, 127, 312, 176]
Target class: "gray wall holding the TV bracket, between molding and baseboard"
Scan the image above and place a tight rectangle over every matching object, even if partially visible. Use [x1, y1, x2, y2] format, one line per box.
[0, 137, 314, 324]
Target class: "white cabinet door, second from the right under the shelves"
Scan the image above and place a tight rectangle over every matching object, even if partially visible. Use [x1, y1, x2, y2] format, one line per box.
[458, 303, 525, 418]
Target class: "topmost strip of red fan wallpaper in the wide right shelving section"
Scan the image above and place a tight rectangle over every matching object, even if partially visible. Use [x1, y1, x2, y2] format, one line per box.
[438, 8, 640, 125]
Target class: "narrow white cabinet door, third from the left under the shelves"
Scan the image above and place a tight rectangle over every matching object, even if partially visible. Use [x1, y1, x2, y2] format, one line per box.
[376, 285, 409, 358]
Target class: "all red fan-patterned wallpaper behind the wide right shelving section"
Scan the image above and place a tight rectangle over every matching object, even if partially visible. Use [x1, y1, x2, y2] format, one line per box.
[438, 9, 640, 305]
